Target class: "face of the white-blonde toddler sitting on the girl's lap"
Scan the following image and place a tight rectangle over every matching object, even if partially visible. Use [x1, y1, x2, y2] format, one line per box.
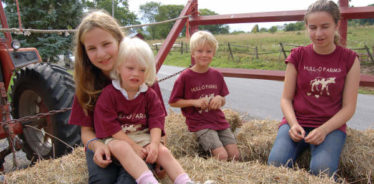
[117, 57, 146, 91]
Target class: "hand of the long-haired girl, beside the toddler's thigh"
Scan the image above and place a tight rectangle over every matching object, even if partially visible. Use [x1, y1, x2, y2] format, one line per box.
[93, 144, 112, 168]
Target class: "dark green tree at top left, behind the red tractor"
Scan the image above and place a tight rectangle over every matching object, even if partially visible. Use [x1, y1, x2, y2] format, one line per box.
[3, 0, 83, 62]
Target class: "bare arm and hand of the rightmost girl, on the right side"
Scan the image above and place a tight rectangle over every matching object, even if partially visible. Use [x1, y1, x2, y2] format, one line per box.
[305, 58, 360, 145]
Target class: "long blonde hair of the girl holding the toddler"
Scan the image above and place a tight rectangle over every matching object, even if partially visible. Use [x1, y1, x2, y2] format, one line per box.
[74, 10, 124, 113]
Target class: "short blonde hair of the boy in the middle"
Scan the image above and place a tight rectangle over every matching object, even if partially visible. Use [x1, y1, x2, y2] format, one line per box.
[190, 31, 218, 53]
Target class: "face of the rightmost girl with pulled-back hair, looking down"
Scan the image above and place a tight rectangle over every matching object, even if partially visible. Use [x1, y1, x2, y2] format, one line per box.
[306, 12, 338, 49]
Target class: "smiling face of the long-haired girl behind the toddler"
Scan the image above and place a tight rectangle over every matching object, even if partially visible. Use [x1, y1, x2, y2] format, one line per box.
[83, 27, 118, 74]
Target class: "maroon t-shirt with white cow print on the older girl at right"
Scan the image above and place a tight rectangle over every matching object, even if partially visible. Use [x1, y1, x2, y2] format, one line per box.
[281, 44, 357, 132]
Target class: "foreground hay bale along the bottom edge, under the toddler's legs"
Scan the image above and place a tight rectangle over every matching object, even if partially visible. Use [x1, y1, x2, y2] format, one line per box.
[5, 147, 334, 184]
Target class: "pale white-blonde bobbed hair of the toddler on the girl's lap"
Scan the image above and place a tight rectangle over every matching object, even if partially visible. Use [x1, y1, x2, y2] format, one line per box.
[110, 37, 156, 86]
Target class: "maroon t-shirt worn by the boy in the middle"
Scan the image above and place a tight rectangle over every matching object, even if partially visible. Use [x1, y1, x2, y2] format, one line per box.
[169, 68, 230, 132]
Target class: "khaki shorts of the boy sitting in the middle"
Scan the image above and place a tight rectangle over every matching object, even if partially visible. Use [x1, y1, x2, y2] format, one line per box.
[195, 128, 236, 151]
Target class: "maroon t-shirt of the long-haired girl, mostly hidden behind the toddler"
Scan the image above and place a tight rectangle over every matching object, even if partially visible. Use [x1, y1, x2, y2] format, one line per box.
[69, 82, 166, 128]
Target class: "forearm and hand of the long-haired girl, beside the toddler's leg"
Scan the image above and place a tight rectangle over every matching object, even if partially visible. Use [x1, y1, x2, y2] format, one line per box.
[81, 126, 112, 168]
